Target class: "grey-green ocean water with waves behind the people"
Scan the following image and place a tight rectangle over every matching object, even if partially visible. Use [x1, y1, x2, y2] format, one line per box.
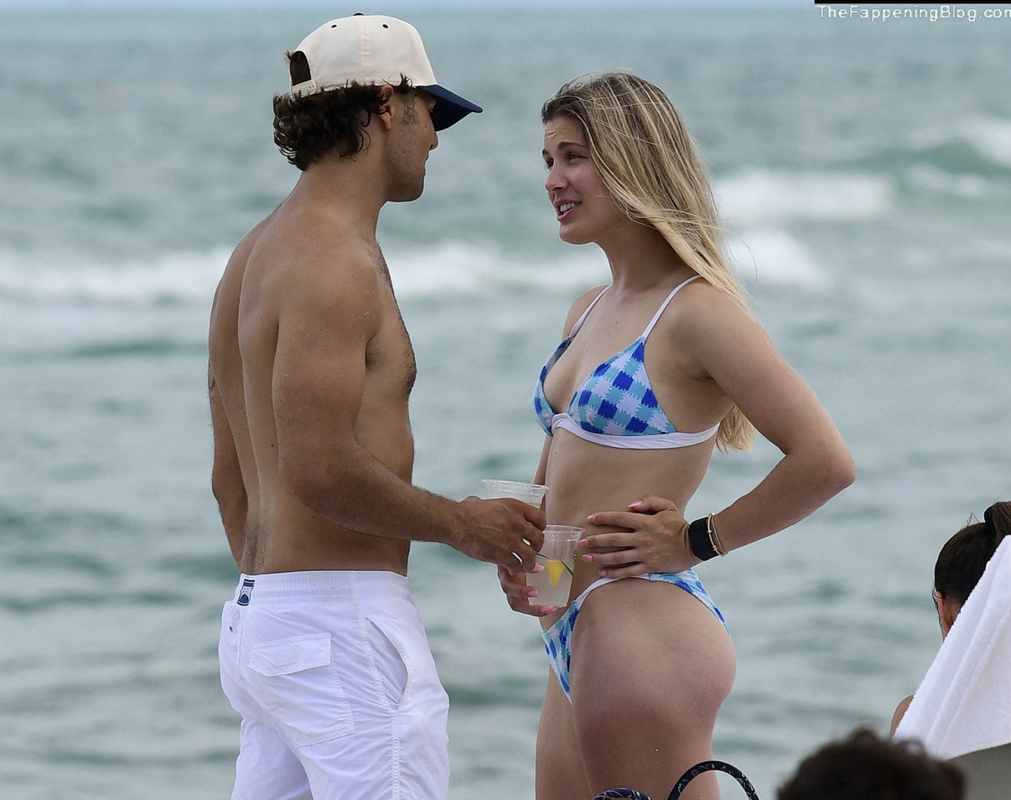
[0, 3, 1011, 800]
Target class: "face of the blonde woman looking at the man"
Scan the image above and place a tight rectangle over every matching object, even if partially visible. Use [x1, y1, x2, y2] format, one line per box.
[542, 116, 629, 245]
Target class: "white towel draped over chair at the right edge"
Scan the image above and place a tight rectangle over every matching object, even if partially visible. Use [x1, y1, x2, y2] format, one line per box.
[895, 537, 1011, 760]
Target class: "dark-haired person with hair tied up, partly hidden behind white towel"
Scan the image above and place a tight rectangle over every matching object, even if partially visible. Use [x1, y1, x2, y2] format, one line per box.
[892, 503, 1011, 734]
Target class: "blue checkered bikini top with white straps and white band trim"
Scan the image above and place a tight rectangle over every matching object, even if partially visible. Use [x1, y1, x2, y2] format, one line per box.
[534, 275, 720, 450]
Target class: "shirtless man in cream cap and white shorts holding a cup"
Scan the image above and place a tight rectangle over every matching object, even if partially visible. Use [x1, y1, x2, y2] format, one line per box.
[209, 15, 544, 800]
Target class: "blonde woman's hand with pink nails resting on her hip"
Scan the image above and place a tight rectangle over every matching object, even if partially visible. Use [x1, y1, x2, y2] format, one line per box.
[579, 496, 699, 579]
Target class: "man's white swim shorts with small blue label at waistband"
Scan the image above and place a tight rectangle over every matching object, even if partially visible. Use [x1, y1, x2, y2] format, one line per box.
[218, 570, 449, 800]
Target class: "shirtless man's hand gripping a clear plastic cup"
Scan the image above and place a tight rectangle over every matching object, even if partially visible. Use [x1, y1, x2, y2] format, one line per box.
[447, 497, 545, 572]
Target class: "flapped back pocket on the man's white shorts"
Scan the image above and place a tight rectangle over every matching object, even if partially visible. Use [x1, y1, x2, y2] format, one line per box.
[249, 633, 355, 747]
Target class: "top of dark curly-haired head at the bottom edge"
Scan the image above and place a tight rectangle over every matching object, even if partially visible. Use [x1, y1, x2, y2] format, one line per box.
[776, 728, 964, 800]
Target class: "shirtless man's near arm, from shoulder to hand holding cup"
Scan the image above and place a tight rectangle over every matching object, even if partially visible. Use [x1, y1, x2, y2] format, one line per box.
[272, 254, 544, 569]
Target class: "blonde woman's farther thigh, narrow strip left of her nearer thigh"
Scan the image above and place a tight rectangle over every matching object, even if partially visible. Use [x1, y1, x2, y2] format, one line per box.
[537, 670, 592, 800]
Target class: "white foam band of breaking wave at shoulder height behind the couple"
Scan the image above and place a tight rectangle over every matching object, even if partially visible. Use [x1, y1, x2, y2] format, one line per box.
[0, 231, 830, 307]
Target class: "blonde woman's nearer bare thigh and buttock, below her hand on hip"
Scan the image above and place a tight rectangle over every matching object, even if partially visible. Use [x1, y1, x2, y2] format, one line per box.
[570, 580, 736, 798]
